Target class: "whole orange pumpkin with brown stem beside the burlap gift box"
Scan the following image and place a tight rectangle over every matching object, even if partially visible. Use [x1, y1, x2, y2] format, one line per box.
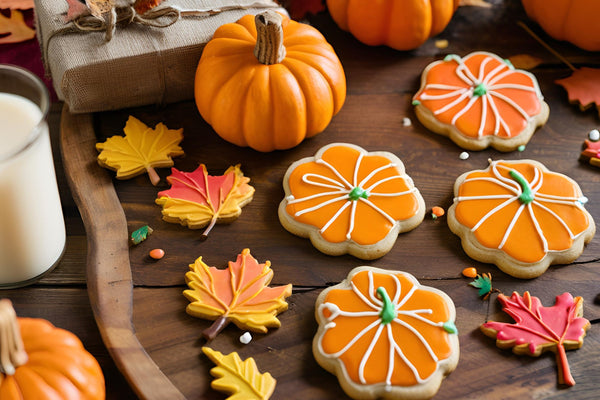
[195, 11, 346, 152]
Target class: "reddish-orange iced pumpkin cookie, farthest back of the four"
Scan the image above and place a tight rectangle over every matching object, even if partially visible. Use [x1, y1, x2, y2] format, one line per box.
[413, 52, 549, 151]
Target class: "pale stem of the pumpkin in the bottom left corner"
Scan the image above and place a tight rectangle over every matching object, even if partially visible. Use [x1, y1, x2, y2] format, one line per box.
[0, 299, 27, 381]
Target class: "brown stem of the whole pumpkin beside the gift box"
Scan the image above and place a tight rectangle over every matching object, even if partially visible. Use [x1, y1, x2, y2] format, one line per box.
[254, 10, 285, 65]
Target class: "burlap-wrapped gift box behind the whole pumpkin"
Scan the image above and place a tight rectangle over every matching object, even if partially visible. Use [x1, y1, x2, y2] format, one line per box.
[35, 0, 285, 113]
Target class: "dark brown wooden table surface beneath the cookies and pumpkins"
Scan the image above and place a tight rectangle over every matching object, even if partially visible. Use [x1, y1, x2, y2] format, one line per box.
[0, 1, 600, 399]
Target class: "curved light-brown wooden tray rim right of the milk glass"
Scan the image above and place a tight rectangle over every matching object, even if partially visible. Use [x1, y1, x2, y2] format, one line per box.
[61, 106, 183, 399]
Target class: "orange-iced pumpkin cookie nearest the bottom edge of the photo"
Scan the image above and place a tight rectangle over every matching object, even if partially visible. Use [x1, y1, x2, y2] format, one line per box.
[313, 267, 459, 399]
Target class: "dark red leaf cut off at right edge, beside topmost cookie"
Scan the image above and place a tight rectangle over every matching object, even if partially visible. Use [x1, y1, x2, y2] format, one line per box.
[556, 67, 600, 113]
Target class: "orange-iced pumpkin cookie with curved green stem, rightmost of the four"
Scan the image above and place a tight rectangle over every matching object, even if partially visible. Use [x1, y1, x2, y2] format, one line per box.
[448, 160, 596, 279]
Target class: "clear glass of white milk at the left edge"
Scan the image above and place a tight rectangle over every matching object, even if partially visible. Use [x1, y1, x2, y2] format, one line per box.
[0, 64, 66, 288]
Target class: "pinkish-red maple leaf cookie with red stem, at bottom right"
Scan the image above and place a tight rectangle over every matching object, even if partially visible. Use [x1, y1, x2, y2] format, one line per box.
[481, 292, 590, 386]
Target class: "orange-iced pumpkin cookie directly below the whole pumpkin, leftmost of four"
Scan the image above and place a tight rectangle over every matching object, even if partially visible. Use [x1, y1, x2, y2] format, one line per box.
[279, 143, 425, 260]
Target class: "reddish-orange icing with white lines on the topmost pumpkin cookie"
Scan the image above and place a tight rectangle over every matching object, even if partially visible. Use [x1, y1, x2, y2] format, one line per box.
[413, 52, 543, 139]
